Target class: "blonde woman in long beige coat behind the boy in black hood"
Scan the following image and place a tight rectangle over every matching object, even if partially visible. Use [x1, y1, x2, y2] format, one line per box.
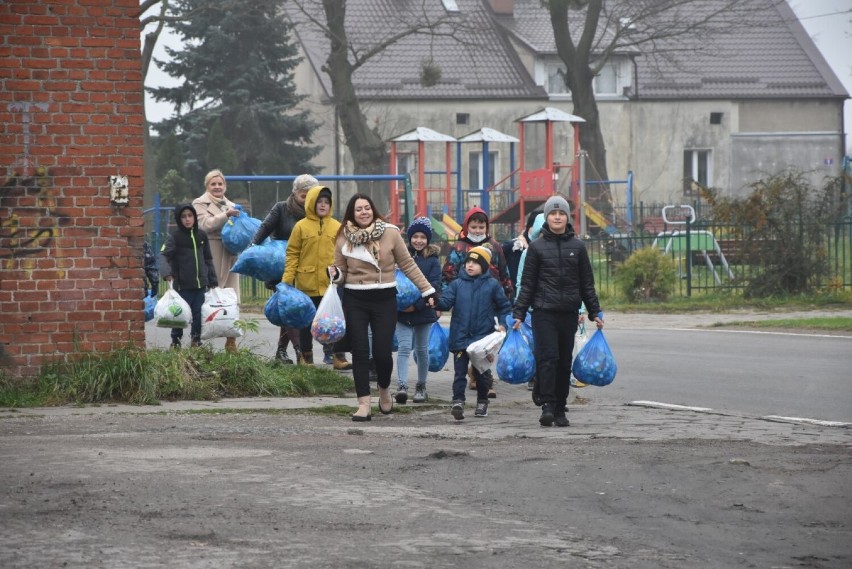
[192, 170, 240, 352]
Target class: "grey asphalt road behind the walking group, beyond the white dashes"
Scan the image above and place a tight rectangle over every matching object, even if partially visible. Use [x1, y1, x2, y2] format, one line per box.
[147, 310, 852, 422]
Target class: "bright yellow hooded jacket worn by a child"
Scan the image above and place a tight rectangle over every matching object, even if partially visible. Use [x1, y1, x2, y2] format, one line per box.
[281, 186, 340, 296]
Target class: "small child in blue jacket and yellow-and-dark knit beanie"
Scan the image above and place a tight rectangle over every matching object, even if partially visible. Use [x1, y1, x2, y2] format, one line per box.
[435, 246, 512, 421]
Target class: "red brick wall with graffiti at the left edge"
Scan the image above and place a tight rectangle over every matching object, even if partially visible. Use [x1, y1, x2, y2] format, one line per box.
[0, 0, 145, 376]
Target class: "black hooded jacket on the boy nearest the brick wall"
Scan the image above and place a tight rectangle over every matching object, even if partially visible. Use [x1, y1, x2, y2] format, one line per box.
[160, 203, 219, 290]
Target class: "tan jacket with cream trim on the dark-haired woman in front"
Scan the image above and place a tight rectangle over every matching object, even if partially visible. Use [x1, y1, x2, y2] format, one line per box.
[334, 224, 435, 297]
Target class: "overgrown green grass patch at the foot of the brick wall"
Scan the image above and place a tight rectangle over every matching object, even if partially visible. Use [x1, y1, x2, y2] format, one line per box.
[0, 347, 353, 407]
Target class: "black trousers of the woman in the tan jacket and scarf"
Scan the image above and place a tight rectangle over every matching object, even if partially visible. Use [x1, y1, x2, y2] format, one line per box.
[338, 288, 397, 397]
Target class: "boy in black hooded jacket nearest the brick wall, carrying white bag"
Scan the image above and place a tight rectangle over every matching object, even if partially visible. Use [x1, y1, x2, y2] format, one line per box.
[160, 204, 219, 349]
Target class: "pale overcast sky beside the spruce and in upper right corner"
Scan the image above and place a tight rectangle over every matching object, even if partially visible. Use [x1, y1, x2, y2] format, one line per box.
[145, 0, 852, 154]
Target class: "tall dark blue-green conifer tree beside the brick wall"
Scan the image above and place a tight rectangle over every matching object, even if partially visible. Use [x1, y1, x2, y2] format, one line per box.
[151, 0, 318, 187]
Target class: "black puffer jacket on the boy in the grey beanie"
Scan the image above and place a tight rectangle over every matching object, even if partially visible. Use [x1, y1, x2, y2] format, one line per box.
[512, 224, 601, 320]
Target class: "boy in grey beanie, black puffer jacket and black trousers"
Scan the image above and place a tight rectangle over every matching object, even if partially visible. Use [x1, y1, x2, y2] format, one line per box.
[512, 196, 603, 427]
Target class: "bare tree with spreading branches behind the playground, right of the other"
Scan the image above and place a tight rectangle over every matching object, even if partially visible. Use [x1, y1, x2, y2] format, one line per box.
[542, 0, 784, 197]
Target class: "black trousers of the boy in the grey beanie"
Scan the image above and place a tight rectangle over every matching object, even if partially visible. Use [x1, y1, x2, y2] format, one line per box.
[532, 310, 580, 411]
